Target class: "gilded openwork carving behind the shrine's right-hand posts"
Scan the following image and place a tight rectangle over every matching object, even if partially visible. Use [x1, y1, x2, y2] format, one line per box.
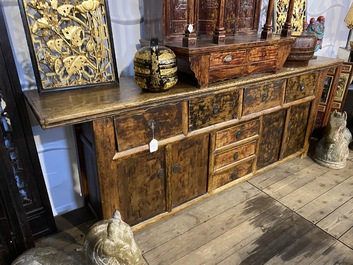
[275, 0, 306, 35]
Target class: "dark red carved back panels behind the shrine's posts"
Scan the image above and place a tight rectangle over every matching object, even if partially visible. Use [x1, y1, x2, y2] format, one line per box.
[144, 0, 261, 41]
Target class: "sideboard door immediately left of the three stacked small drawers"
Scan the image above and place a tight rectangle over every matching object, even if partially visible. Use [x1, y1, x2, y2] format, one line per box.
[168, 135, 209, 207]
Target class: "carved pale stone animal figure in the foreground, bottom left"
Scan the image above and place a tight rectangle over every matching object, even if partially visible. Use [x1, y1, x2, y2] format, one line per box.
[12, 211, 146, 265]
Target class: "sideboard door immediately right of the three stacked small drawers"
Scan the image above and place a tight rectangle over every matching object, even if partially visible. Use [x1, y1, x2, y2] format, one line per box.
[256, 110, 286, 169]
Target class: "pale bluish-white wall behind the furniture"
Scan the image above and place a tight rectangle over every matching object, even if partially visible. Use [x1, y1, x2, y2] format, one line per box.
[1, 0, 353, 214]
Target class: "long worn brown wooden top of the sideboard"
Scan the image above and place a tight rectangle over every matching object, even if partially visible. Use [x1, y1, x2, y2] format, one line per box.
[24, 57, 342, 129]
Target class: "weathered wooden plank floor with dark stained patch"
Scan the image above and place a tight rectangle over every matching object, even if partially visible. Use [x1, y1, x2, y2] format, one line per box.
[37, 148, 353, 265]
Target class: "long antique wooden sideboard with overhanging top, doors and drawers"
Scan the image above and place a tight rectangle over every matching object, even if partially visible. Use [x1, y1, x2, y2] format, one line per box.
[25, 57, 342, 225]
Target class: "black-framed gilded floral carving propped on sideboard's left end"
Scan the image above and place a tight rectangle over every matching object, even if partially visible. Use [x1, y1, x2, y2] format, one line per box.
[19, 0, 118, 92]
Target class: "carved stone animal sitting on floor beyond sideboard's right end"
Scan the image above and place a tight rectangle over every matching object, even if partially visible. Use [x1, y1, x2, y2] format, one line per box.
[314, 111, 352, 169]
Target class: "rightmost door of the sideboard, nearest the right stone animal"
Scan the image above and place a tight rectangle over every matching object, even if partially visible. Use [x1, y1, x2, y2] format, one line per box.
[281, 102, 311, 158]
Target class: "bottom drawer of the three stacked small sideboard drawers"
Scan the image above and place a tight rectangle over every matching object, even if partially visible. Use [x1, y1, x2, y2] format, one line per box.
[209, 159, 255, 191]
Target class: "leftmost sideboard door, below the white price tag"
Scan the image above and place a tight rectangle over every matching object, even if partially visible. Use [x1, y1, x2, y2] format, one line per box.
[117, 148, 166, 225]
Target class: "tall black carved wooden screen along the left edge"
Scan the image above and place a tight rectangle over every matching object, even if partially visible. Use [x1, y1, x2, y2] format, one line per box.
[0, 2, 56, 243]
